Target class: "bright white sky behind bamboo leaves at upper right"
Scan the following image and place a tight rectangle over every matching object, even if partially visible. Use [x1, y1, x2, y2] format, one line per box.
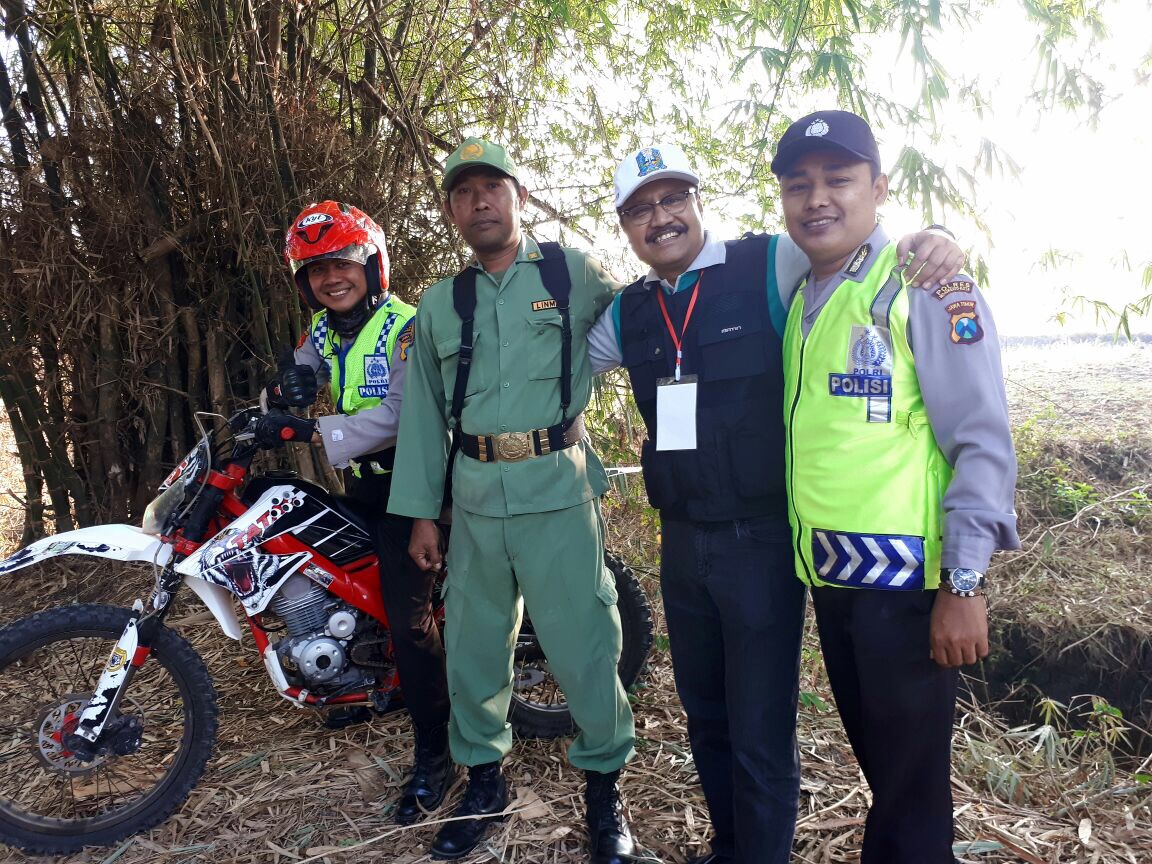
[873, 0, 1152, 335]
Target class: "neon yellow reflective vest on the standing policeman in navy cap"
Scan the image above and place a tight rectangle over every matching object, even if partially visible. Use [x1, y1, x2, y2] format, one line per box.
[783, 244, 952, 590]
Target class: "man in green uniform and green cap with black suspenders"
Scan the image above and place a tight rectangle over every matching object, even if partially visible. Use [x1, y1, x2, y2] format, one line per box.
[388, 138, 635, 864]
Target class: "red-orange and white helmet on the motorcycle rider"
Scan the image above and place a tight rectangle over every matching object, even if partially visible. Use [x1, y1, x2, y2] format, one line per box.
[285, 200, 388, 310]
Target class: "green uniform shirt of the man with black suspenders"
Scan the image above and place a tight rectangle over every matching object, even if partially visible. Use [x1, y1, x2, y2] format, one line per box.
[388, 236, 620, 518]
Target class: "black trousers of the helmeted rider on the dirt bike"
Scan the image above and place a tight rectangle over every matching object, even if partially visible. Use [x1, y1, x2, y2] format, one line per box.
[346, 471, 448, 729]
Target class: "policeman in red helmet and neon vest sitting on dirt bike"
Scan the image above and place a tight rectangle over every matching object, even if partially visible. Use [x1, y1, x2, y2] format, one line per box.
[257, 200, 452, 825]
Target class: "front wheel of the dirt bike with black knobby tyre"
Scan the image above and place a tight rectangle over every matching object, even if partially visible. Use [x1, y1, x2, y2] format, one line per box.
[0, 605, 217, 855]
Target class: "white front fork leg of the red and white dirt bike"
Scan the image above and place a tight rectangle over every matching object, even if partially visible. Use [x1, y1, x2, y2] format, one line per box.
[73, 563, 182, 744]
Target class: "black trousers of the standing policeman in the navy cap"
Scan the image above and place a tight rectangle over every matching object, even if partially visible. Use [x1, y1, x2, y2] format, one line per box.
[812, 588, 960, 864]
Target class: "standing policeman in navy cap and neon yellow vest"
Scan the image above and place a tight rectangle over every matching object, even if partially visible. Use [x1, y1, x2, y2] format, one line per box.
[772, 111, 1018, 864]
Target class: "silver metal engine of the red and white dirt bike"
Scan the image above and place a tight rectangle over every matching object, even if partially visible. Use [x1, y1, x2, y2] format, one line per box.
[270, 573, 364, 690]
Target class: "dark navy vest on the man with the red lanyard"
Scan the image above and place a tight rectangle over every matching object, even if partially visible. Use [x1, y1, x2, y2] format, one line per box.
[620, 234, 788, 522]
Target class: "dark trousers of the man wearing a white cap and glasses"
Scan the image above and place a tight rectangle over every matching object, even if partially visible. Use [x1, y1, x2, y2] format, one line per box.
[660, 516, 804, 864]
